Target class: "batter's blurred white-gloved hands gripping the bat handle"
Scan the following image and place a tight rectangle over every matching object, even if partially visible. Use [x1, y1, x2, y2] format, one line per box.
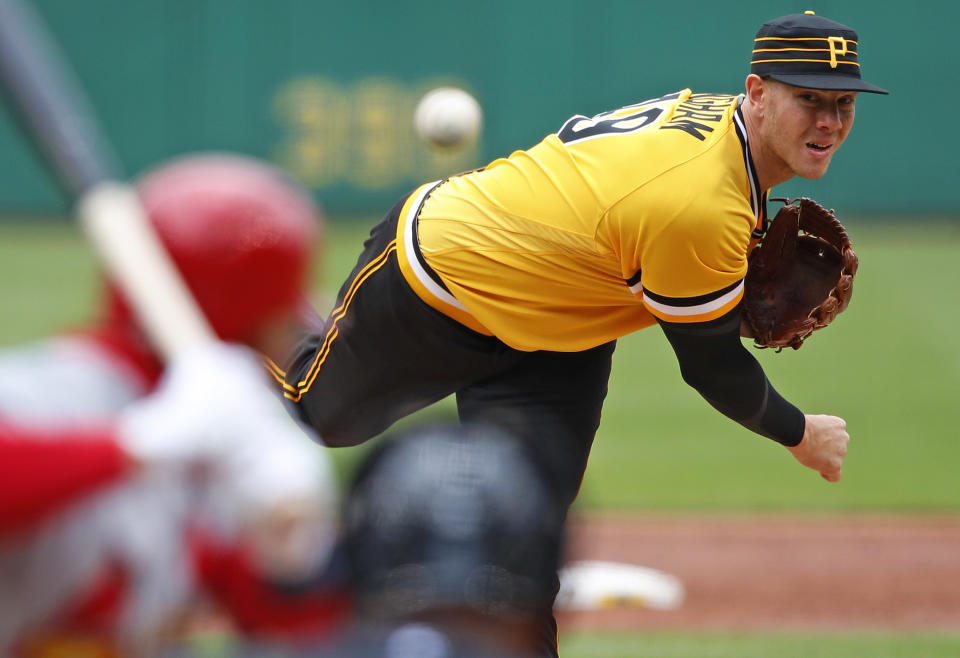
[117, 341, 338, 581]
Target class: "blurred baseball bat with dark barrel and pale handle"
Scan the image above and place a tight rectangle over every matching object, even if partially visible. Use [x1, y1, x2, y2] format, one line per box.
[0, 0, 214, 358]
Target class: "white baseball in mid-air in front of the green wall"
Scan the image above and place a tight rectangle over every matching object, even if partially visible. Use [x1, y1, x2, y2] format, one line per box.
[413, 87, 483, 147]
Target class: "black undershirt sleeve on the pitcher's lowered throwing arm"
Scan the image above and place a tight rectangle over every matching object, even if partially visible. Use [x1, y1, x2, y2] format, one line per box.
[660, 307, 805, 446]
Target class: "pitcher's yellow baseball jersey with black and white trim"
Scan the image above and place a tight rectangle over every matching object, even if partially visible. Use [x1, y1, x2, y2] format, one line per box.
[397, 89, 766, 351]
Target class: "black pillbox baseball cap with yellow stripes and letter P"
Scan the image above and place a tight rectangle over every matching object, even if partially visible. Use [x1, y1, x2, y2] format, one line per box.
[750, 11, 890, 94]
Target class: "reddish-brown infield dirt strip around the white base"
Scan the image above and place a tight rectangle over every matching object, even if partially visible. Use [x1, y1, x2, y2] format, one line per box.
[559, 514, 960, 631]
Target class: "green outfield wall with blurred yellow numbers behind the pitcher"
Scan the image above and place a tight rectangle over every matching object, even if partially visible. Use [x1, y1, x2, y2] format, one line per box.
[0, 0, 948, 215]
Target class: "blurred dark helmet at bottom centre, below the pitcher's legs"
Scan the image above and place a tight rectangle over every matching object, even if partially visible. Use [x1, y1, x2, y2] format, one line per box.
[344, 425, 564, 618]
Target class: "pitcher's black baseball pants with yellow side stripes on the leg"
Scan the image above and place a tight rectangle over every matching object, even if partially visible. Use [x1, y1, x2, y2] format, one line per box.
[286, 192, 616, 655]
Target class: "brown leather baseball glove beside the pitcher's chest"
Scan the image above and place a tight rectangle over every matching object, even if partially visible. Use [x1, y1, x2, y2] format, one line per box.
[742, 198, 859, 352]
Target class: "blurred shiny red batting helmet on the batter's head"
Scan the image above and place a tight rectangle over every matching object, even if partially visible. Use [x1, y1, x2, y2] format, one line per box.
[108, 153, 321, 341]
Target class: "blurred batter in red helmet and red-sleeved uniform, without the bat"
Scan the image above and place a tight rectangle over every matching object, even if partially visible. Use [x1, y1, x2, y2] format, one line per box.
[0, 154, 349, 657]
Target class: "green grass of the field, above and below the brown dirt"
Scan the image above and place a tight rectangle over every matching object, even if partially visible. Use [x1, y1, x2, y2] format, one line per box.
[0, 213, 960, 658]
